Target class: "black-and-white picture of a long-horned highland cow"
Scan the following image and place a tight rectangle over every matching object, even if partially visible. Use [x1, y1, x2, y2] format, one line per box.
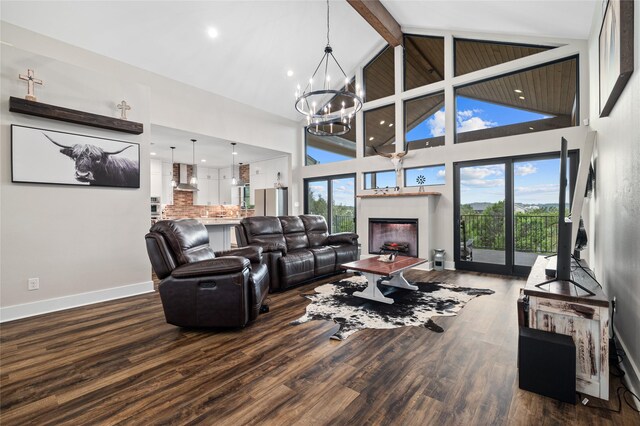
[11, 124, 140, 188]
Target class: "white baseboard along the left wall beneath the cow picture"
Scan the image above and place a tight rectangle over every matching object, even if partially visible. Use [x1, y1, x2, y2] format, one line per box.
[0, 281, 154, 323]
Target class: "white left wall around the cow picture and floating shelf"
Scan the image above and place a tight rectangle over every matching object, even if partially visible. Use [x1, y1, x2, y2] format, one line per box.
[0, 22, 301, 320]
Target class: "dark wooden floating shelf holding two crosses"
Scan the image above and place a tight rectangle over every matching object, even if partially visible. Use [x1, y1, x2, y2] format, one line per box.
[9, 96, 143, 135]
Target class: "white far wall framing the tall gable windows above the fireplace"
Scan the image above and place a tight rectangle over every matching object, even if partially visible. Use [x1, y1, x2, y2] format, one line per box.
[298, 28, 589, 267]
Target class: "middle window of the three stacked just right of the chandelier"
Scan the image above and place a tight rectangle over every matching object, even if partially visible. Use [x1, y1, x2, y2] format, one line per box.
[363, 104, 396, 157]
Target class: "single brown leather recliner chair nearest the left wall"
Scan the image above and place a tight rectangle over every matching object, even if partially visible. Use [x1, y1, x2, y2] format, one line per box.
[145, 219, 269, 327]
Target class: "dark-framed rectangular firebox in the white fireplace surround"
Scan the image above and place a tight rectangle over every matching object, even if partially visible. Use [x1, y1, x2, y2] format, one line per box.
[369, 218, 418, 257]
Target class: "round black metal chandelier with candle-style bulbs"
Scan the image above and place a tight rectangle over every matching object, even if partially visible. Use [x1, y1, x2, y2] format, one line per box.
[296, 0, 362, 136]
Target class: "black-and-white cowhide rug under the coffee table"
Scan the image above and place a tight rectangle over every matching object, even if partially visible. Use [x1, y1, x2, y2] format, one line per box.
[291, 276, 494, 340]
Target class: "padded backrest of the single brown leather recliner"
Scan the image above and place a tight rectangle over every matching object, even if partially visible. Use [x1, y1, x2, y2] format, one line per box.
[150, 219, 216, 265]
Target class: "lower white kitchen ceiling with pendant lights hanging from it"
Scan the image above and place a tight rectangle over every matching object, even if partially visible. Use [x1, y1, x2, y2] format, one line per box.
[150, 125, 287, 168]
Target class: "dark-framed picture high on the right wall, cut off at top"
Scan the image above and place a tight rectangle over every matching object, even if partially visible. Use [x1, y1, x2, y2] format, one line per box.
[598, 0, 634, 117]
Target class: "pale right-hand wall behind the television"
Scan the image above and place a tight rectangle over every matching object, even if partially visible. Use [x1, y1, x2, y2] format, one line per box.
[589, 2, 640, 396]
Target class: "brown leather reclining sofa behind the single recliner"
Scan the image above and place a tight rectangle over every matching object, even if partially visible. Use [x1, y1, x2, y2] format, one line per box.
[236, 215, 358, 291]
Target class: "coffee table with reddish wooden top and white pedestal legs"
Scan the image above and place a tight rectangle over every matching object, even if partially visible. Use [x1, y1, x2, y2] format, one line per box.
[340, 256, 427, 304]
